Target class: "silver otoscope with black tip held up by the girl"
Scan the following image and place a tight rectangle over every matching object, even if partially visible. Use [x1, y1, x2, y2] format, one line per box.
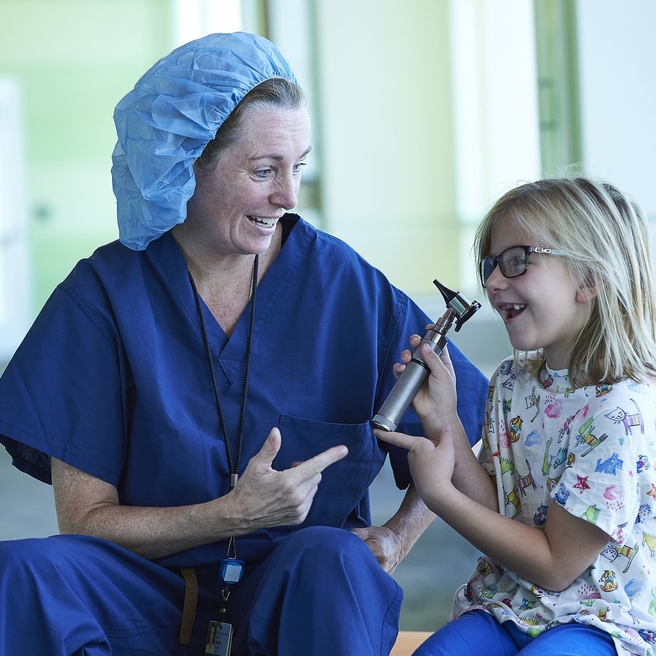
[371, 280, 481, 431]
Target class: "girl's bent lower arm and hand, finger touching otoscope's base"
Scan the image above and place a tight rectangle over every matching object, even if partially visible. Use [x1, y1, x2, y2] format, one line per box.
[376, 427, 610, 591]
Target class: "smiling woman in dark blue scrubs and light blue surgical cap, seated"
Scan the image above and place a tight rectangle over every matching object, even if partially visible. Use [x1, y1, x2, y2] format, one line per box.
[0, 33, 487, 656]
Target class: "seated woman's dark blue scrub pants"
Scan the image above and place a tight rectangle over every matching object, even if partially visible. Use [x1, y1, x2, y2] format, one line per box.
[0, 527, 403, 656]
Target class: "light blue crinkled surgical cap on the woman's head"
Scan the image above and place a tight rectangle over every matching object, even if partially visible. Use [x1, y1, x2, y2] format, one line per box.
[112, 32, 297, 250]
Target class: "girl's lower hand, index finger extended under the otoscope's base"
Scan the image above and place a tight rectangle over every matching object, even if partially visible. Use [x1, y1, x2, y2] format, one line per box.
[374, 426, 456, 512]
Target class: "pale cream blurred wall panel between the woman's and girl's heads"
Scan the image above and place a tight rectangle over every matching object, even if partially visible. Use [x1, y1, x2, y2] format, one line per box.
[315, 0, 458, 295]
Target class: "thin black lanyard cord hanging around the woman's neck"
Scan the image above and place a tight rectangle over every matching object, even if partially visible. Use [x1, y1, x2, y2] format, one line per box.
[189, 255, 259, 489]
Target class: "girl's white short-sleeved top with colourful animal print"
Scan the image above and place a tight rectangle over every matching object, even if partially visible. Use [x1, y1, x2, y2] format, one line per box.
[452, 359, 656, 656]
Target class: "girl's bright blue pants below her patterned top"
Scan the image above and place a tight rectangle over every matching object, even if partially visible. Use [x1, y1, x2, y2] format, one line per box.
[413, 610, 617, 656]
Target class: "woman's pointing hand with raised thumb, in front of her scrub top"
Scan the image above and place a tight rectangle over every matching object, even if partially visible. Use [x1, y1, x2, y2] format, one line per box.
[228, 428, 348, 530]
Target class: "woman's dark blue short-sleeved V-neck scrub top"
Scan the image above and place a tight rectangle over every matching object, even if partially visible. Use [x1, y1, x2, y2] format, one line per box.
[0, 215, 487, 565]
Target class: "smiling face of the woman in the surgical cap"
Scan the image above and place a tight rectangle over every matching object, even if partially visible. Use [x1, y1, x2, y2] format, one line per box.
[177, 105, 311, 257]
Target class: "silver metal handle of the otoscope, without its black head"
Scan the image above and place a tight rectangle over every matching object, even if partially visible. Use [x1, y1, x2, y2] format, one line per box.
[371, 308, 456, 431]
